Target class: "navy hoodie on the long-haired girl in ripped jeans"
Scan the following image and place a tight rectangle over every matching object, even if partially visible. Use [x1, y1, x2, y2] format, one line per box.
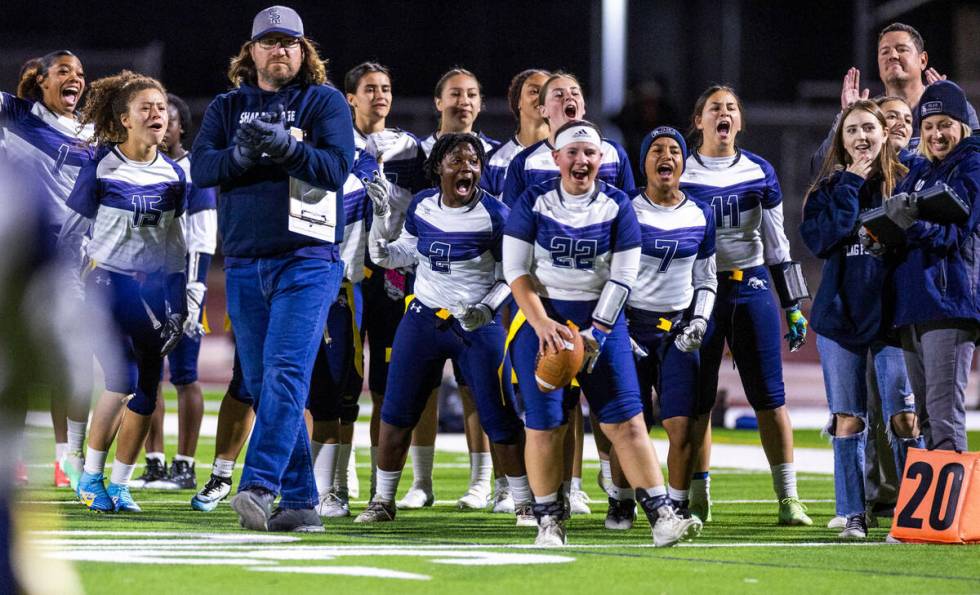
[800, 171, 896, 348]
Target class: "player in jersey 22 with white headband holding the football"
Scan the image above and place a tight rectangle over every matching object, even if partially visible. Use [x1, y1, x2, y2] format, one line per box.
[504, 120, 701, 546]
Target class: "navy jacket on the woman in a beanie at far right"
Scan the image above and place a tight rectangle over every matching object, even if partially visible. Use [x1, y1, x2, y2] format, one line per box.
[895, 136, 980, 326]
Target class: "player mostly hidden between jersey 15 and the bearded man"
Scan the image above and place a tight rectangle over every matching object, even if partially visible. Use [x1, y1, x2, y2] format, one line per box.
[129, 93, 218, 490]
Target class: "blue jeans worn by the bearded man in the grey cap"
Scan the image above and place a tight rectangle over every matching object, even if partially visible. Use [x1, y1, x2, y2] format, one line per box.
[225, 255, 344, 508]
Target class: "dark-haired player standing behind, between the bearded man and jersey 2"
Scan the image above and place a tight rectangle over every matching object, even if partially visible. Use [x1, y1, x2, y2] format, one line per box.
[344, 62, 432, 502]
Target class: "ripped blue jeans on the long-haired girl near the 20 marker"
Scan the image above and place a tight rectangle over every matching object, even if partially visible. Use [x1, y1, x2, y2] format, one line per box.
[817, 336, 922, 516]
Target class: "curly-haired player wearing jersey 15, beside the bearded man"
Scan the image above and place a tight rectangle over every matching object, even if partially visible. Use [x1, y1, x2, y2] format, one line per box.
[59, 71, 187, 512]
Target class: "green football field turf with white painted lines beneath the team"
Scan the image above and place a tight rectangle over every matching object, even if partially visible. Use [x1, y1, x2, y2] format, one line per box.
[18, 400, 980, 595]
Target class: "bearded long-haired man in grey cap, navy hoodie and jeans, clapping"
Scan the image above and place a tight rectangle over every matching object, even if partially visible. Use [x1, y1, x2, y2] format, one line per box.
[191, 6, 354, 531]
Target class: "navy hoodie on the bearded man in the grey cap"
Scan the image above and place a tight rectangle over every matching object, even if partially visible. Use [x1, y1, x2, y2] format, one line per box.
[191, 83, 354, 258]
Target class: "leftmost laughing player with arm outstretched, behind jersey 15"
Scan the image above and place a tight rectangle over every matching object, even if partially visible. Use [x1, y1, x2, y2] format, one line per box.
[0, 50, 92, 489]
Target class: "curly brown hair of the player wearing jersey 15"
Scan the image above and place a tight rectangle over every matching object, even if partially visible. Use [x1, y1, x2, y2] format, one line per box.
[80, 70, 167, 144]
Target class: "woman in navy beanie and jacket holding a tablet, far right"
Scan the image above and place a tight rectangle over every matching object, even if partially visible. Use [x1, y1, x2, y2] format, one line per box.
[885, 81, 980, 451]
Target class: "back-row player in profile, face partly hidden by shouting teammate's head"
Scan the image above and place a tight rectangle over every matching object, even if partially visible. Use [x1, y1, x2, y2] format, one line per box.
[480, 68, 551, 198]
